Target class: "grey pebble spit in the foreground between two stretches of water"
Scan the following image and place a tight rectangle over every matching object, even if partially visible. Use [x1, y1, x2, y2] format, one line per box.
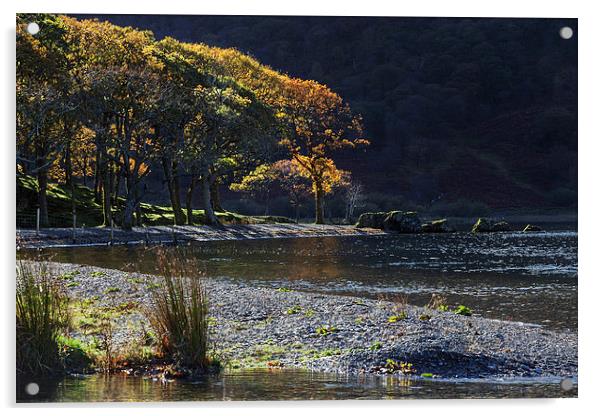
[36, 263, 577, 378]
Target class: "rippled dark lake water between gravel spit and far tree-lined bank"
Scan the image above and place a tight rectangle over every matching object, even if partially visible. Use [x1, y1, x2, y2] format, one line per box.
[27, 231, 577, 330]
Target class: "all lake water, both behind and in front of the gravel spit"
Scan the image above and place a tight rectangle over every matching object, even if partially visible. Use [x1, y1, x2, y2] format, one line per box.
[19, 231, 578, 401]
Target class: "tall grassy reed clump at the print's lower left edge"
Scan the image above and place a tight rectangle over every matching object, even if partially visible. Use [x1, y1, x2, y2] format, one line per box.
[16, 262, 69, 374]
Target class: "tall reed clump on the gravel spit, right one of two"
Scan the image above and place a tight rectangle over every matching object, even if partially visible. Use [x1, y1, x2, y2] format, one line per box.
[145, 249, 211, 369]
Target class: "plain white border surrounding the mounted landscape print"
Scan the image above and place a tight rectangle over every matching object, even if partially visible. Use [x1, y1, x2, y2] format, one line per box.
[0, 0, 602, 416]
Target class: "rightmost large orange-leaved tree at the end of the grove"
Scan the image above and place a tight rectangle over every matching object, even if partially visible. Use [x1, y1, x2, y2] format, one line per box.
[280, 78, 368, 224]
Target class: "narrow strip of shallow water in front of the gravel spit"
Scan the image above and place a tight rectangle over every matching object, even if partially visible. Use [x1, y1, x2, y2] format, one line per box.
[18, 370, 577, 402]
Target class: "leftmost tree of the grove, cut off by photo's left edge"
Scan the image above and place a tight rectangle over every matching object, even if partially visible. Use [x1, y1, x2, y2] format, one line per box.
[16, 15, 78, 226]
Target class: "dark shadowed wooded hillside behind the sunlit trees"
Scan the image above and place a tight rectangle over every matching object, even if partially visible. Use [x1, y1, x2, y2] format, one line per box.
[77, 15, 577, 213]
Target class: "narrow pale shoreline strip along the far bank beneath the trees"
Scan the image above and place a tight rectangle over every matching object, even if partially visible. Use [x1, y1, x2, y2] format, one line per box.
[16, 224, 386, 249]
